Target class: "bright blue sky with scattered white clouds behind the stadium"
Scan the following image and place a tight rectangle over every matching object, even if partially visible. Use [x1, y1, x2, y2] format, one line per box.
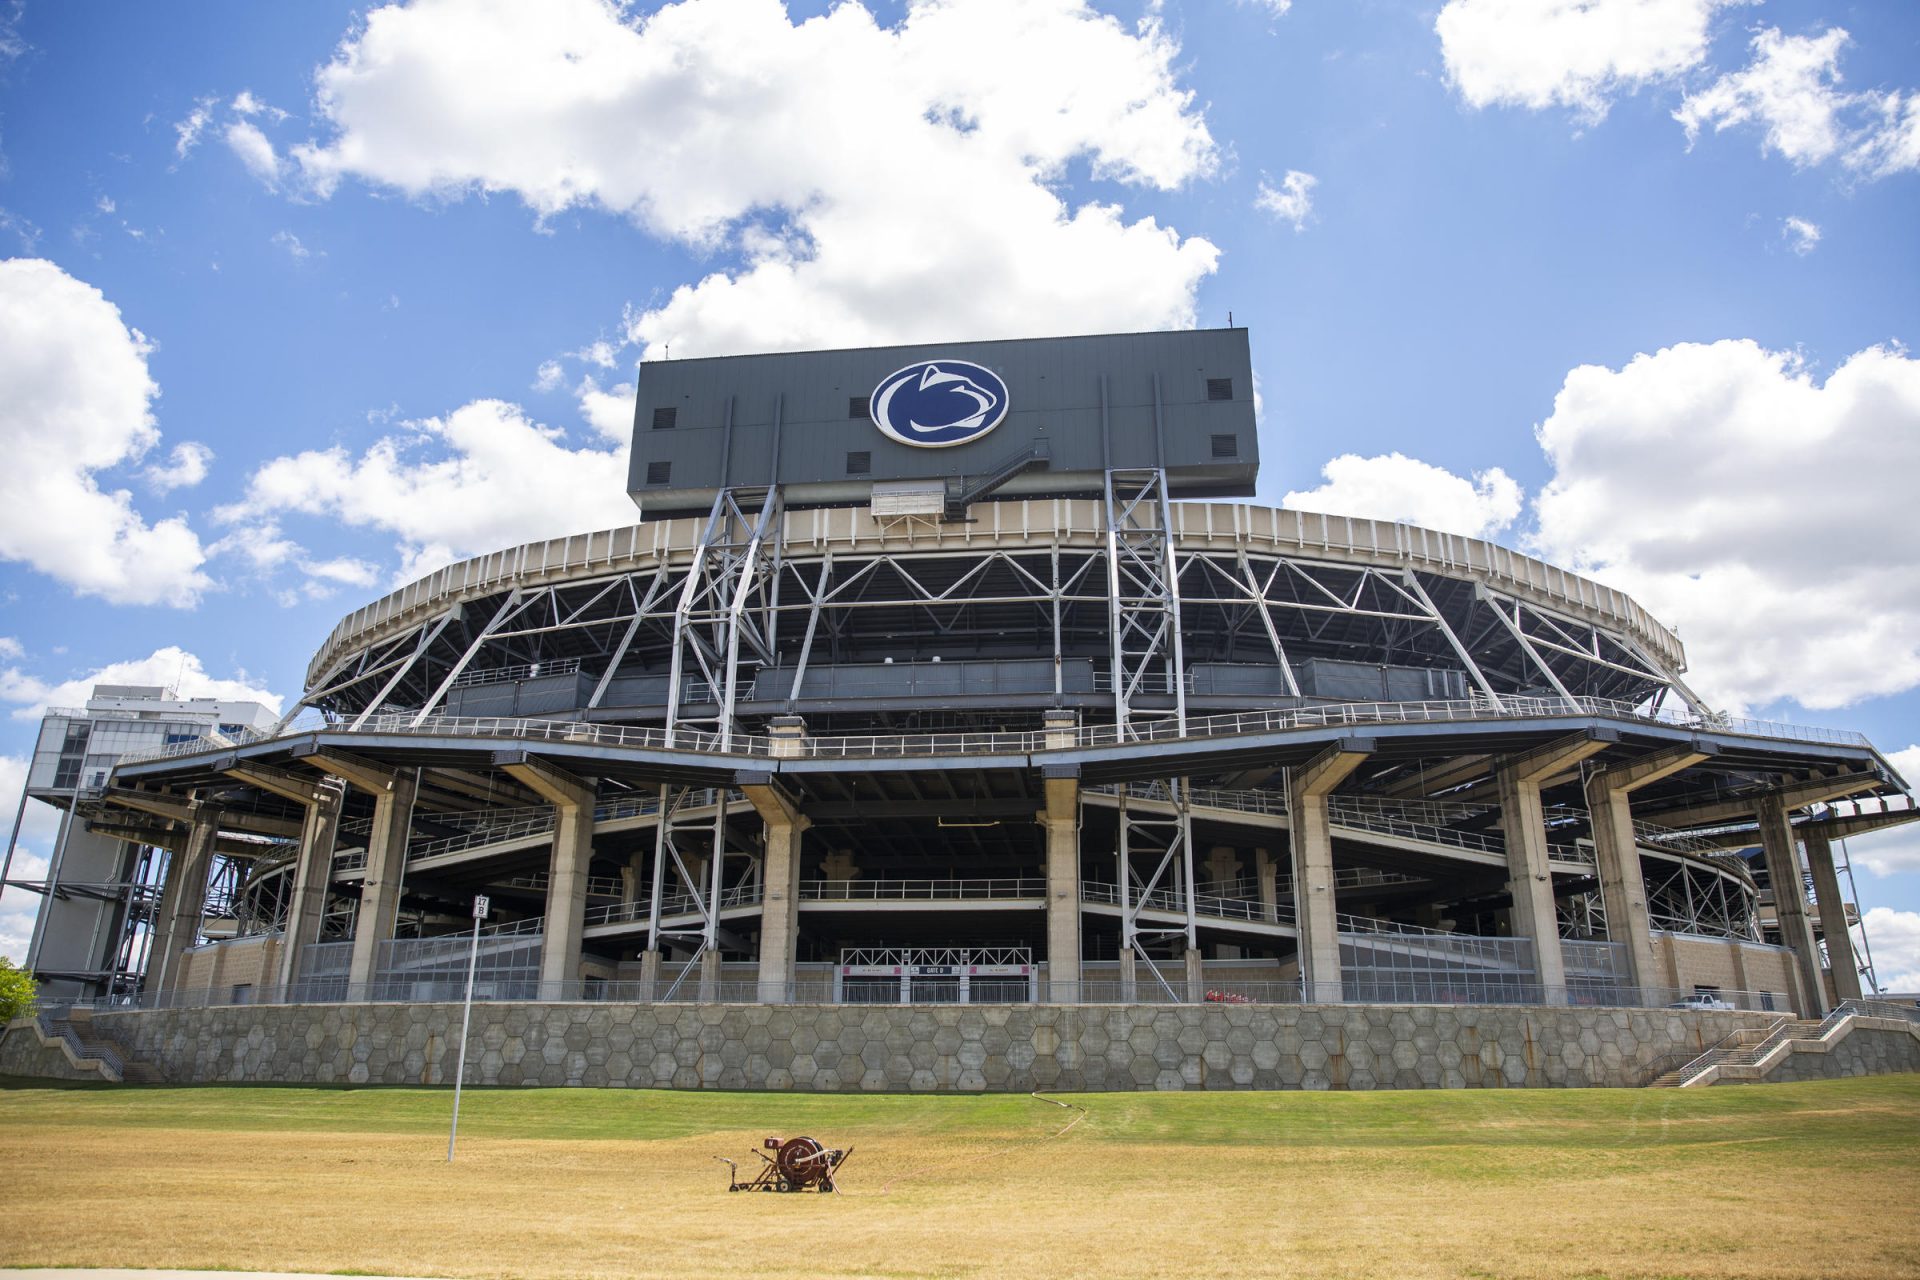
[0, 0, 1920, 983]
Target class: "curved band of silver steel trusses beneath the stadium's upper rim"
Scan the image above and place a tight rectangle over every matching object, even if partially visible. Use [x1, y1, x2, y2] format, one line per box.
[307, 521, 1688, 731]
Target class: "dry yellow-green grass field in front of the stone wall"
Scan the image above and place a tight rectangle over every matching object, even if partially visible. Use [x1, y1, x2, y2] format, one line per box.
[0, 1077, 1920, 1278]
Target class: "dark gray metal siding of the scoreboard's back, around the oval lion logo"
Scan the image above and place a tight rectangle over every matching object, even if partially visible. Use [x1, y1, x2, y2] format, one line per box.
[628, 328, 1260, 518]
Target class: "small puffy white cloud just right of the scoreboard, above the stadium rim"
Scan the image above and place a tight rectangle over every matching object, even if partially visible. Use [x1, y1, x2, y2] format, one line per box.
[1281, 453, 1521, 537]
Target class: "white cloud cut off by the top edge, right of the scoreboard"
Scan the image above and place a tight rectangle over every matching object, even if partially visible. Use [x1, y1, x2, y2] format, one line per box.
[1434, 0, 1745, 121]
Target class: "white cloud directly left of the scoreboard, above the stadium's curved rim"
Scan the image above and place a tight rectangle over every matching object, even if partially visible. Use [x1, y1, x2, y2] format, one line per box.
[219, 399, 636, 578]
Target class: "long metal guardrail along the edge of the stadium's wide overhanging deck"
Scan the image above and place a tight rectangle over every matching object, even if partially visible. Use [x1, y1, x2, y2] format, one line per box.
[121, 697, 1868, 764]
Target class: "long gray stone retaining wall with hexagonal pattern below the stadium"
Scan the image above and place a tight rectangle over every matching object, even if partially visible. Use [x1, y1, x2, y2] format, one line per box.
[63, 1004, 1764, 1092]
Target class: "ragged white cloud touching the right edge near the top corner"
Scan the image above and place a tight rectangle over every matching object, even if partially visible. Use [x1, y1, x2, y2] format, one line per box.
[1674, 27, 1920, 178]
